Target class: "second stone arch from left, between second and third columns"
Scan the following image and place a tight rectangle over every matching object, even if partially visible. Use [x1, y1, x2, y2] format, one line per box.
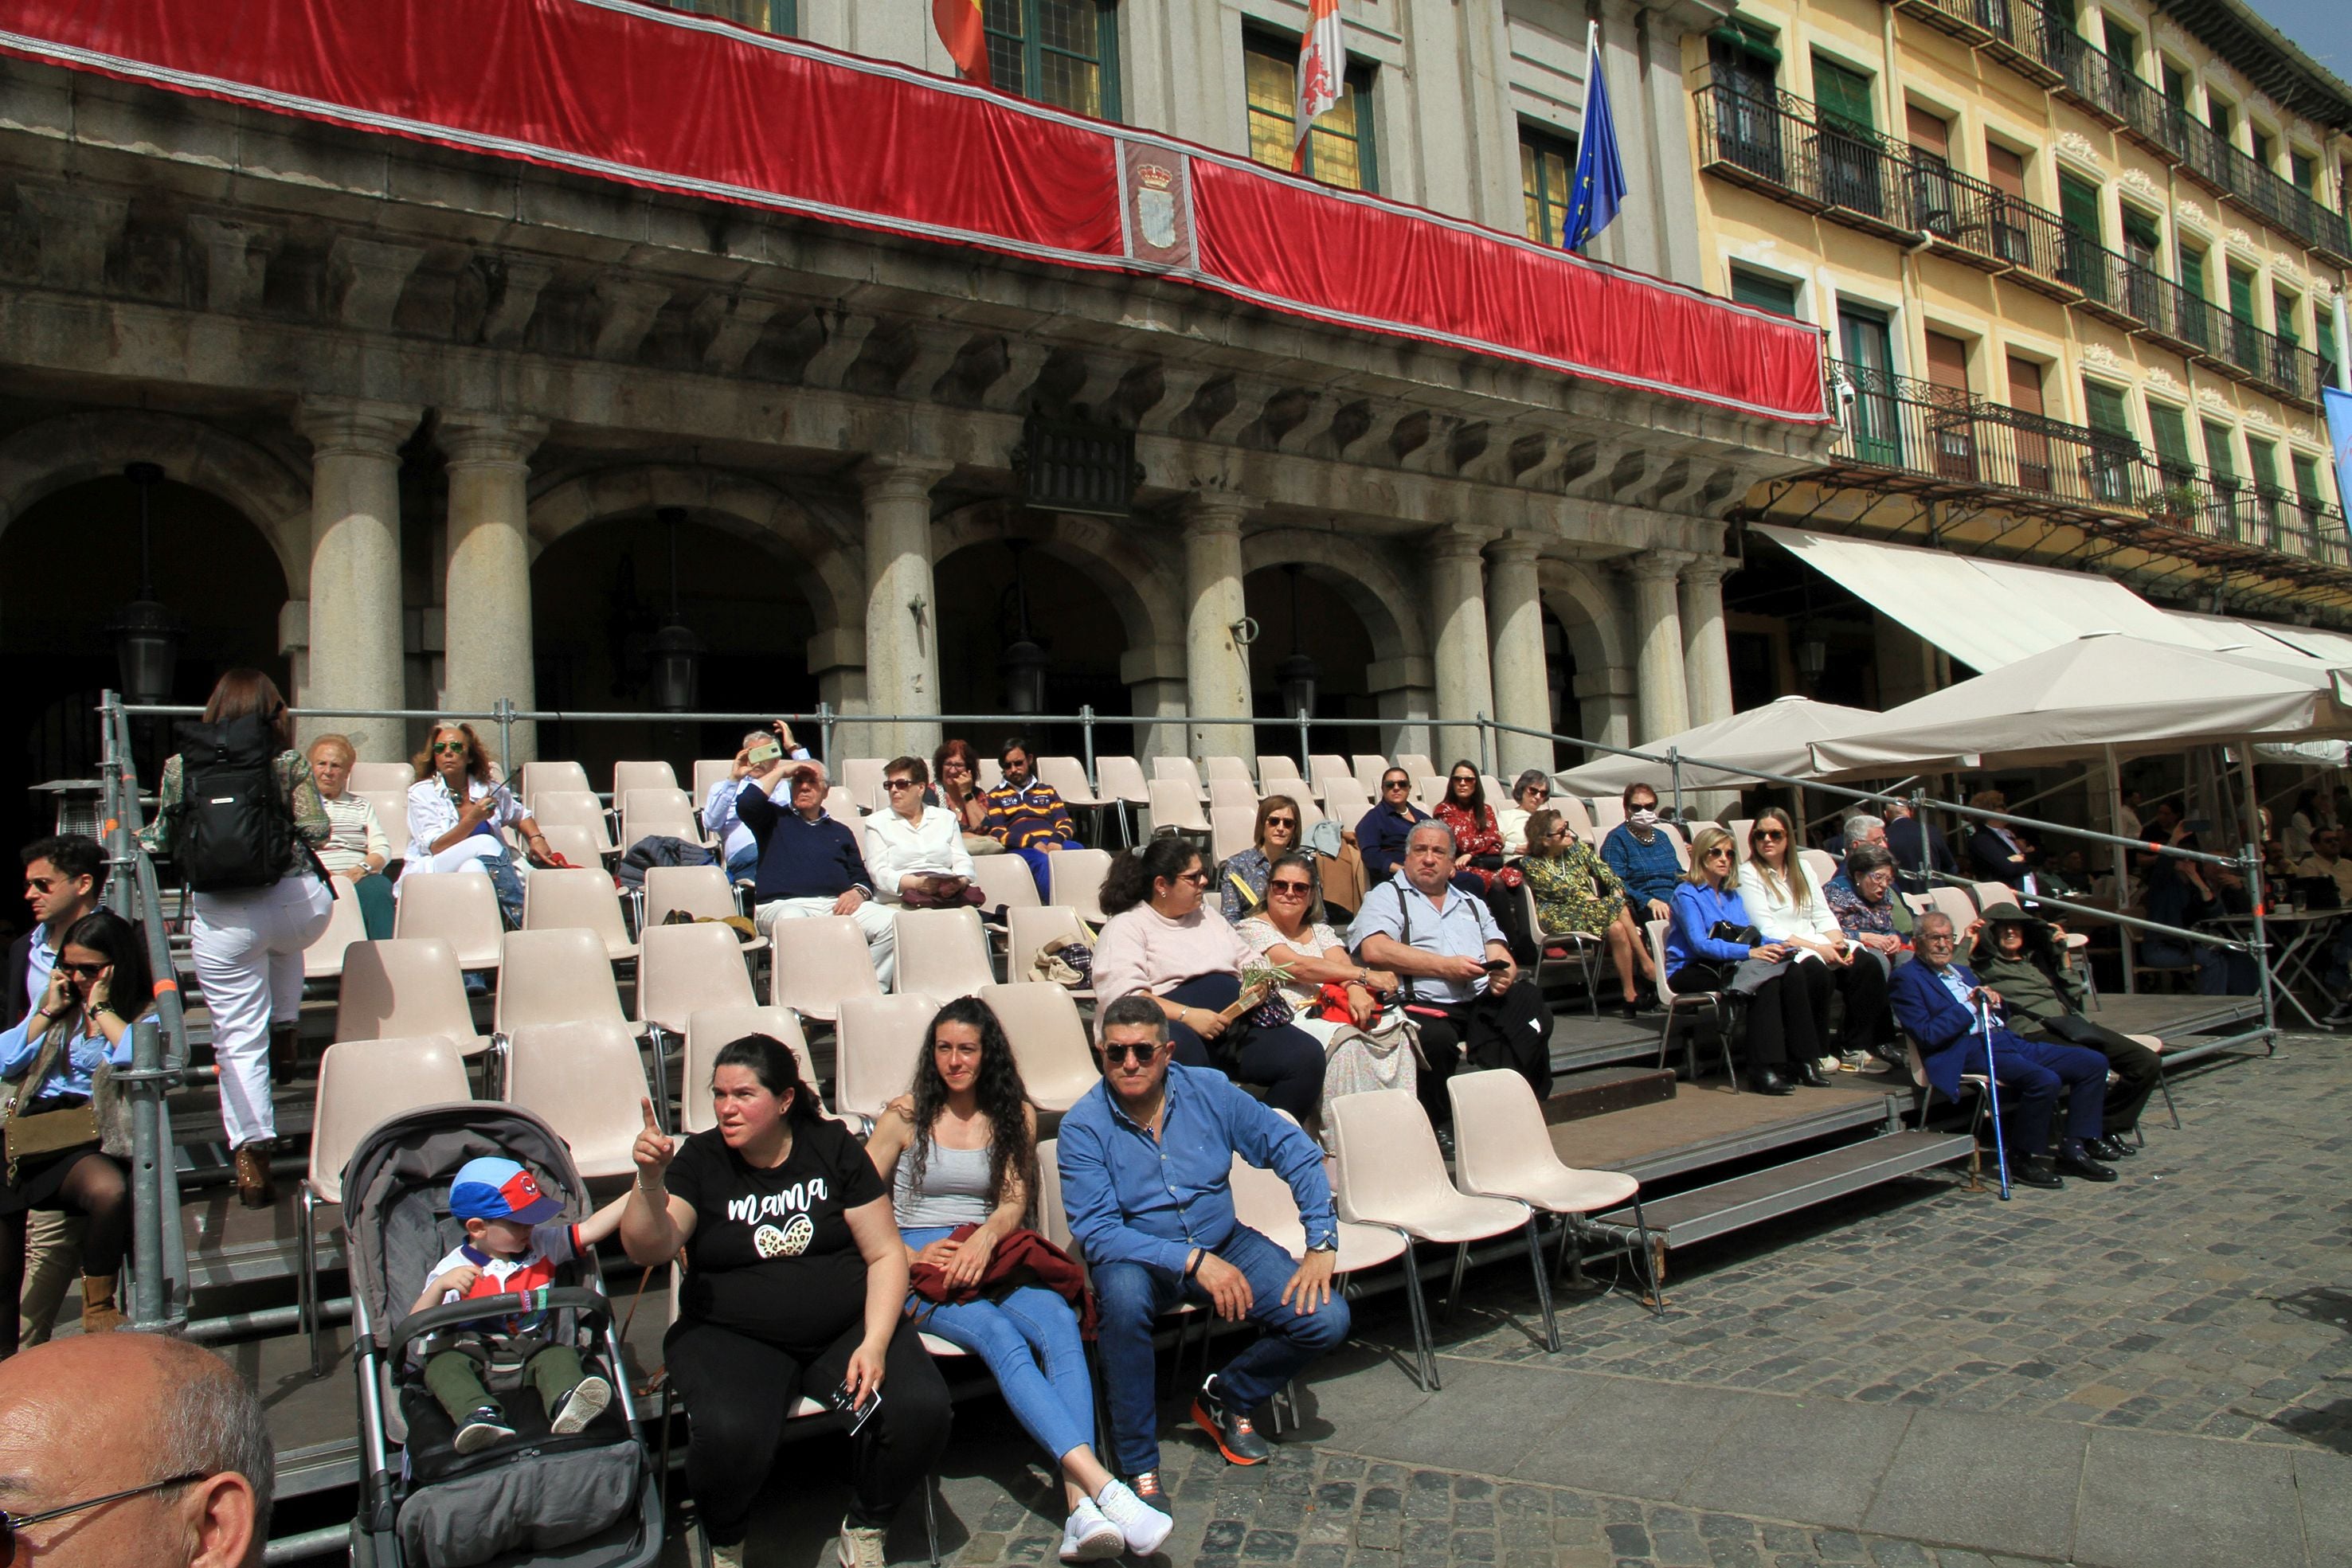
[529, 463, 866, 637]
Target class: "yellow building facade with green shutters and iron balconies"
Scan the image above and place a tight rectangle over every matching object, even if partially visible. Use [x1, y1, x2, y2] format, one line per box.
[1684, 0, 2352, 701]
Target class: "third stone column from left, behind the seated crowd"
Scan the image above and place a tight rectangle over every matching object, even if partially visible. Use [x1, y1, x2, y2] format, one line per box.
[859, 459, 948, 760]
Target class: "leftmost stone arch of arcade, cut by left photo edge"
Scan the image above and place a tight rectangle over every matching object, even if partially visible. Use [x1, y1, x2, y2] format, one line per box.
[0, 409, 311, 585]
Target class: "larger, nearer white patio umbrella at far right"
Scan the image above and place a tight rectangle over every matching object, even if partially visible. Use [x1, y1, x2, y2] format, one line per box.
[1811, 632, 2352, 778]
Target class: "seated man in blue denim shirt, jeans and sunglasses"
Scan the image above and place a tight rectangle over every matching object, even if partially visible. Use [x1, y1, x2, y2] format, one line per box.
[1061, 992, 1348, 1509]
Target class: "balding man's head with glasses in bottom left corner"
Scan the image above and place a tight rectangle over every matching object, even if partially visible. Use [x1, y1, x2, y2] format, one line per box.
[0, 1333, 273, 1568]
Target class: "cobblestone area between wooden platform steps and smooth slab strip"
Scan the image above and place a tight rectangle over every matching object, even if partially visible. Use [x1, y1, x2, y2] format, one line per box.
[1451, 1037, 2352, 1453]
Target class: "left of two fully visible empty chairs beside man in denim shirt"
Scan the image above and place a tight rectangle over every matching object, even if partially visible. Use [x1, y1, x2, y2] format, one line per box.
[1326, 1089, 1560, 1390]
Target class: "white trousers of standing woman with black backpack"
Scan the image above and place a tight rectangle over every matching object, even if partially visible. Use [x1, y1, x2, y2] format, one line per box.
[190, 872, 334, 1150]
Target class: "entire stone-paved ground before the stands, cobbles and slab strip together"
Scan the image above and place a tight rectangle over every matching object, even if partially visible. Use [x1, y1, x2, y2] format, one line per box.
[705, 1037, 2352, 1568]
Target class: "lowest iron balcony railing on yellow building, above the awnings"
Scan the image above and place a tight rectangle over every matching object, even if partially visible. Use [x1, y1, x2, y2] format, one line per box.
[1827, 360, 2352, 566]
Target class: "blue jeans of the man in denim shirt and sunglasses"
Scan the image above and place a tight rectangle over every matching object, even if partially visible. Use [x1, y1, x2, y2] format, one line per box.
[1094, 1225, 1348, 1476]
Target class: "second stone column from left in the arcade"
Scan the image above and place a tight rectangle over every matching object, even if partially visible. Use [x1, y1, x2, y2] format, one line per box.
[440, 412, 548, 771]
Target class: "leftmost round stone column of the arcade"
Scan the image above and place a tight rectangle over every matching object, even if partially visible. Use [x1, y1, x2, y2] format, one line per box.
[294, 397, 424, 761]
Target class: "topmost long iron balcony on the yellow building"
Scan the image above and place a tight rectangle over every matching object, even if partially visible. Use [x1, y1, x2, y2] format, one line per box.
[1896, 0, 2352, 266]
